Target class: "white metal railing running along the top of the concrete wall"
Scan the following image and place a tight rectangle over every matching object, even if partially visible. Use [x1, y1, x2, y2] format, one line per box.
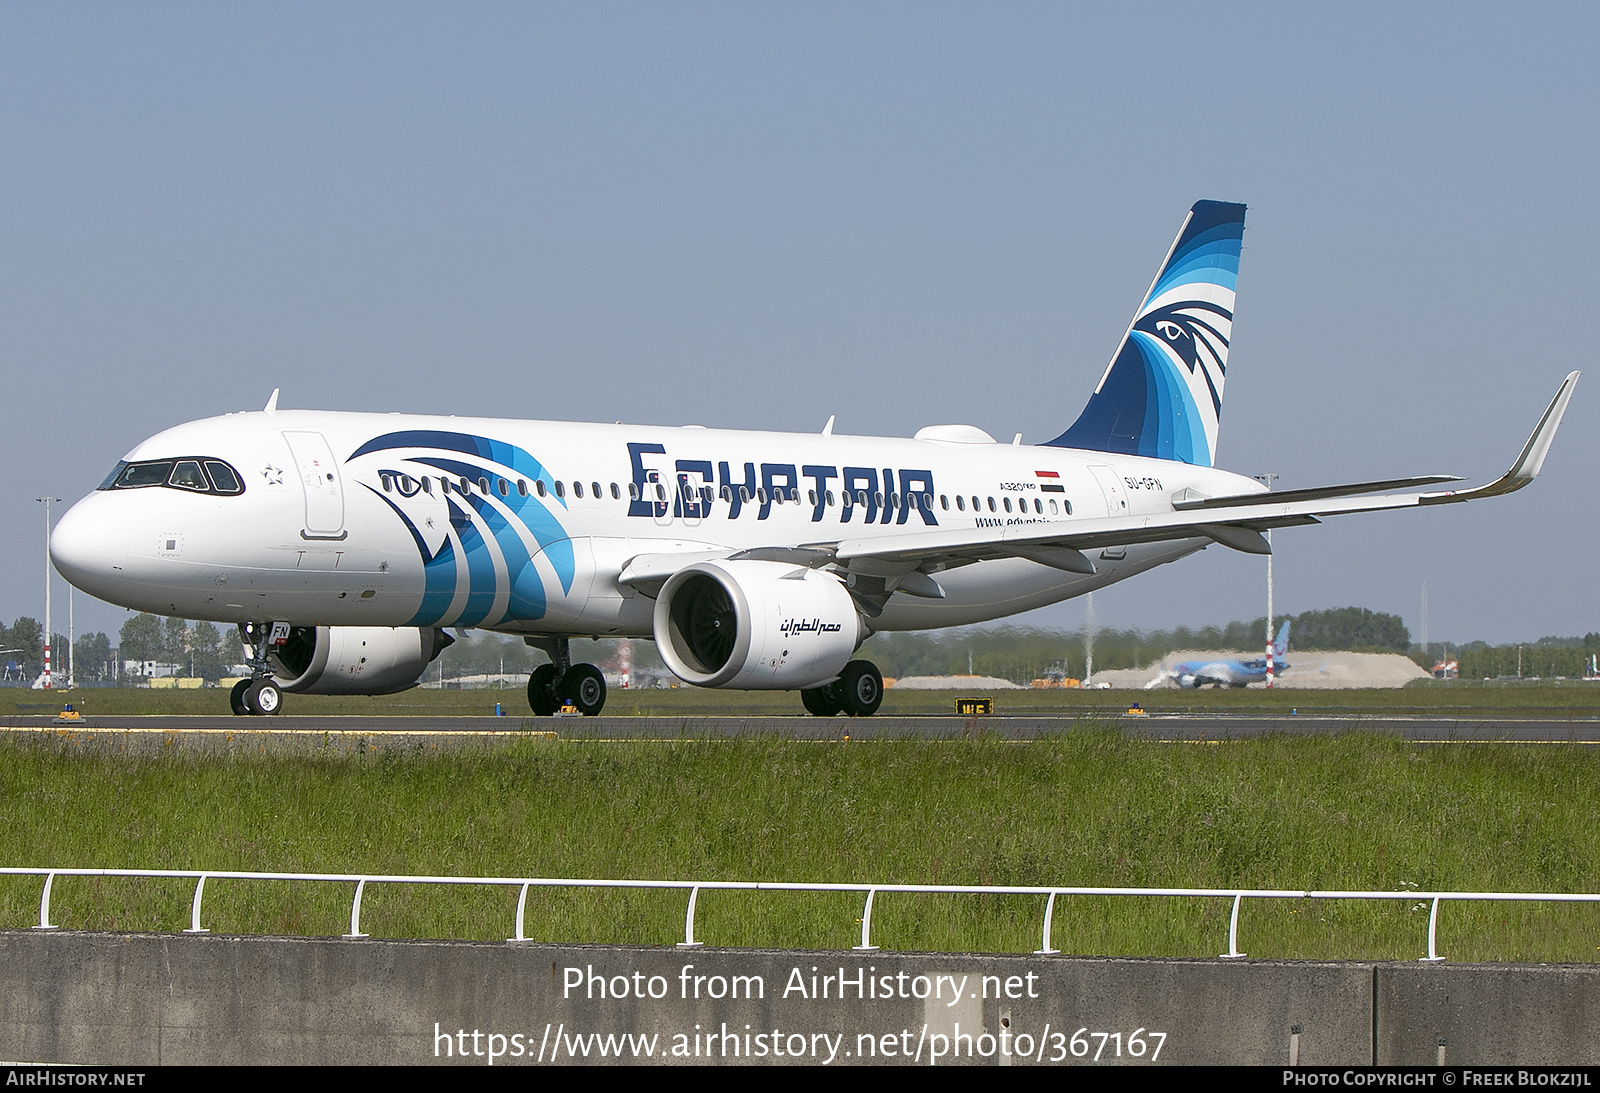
[0, 867, 1600, 960]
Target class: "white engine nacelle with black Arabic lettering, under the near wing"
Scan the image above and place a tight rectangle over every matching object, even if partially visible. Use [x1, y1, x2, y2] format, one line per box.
[654, 562, 867, 690]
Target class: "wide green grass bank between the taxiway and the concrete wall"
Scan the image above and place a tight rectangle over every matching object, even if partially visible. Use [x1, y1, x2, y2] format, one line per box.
[0, 729, 1600, 962]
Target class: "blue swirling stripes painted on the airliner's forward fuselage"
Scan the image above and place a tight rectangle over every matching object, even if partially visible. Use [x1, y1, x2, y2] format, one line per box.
[350, 429, 574, 626]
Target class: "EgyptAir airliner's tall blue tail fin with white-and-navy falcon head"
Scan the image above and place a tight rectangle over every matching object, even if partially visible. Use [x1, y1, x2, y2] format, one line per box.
[1045, 202, 1245, 467]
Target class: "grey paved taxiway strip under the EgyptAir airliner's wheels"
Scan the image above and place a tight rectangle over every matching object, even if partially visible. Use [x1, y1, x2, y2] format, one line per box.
[0, 714, 1600, 752]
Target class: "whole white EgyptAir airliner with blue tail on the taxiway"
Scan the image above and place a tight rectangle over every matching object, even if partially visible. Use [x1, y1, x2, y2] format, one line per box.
[51, 202, 1578, 715]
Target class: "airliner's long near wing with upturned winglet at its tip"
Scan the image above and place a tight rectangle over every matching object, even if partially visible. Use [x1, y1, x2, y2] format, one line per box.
[830, 371, 1579, 572]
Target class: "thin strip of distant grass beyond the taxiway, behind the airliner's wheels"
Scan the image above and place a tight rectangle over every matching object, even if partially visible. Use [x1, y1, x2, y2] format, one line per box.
[12, 680, 1600, 717]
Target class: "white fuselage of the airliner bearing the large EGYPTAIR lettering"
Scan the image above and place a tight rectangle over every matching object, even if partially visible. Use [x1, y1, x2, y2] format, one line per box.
[51, 410, 1261, 637]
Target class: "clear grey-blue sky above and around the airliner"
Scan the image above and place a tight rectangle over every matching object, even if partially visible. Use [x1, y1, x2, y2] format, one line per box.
[0, 3, 1600, 642]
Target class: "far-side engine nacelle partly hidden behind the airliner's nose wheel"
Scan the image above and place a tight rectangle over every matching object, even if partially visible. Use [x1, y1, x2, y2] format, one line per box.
[270, 626, 456, 695]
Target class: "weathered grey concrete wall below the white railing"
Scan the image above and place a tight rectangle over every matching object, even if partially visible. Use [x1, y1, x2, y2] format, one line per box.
[0, 931, 1600, 1066]
